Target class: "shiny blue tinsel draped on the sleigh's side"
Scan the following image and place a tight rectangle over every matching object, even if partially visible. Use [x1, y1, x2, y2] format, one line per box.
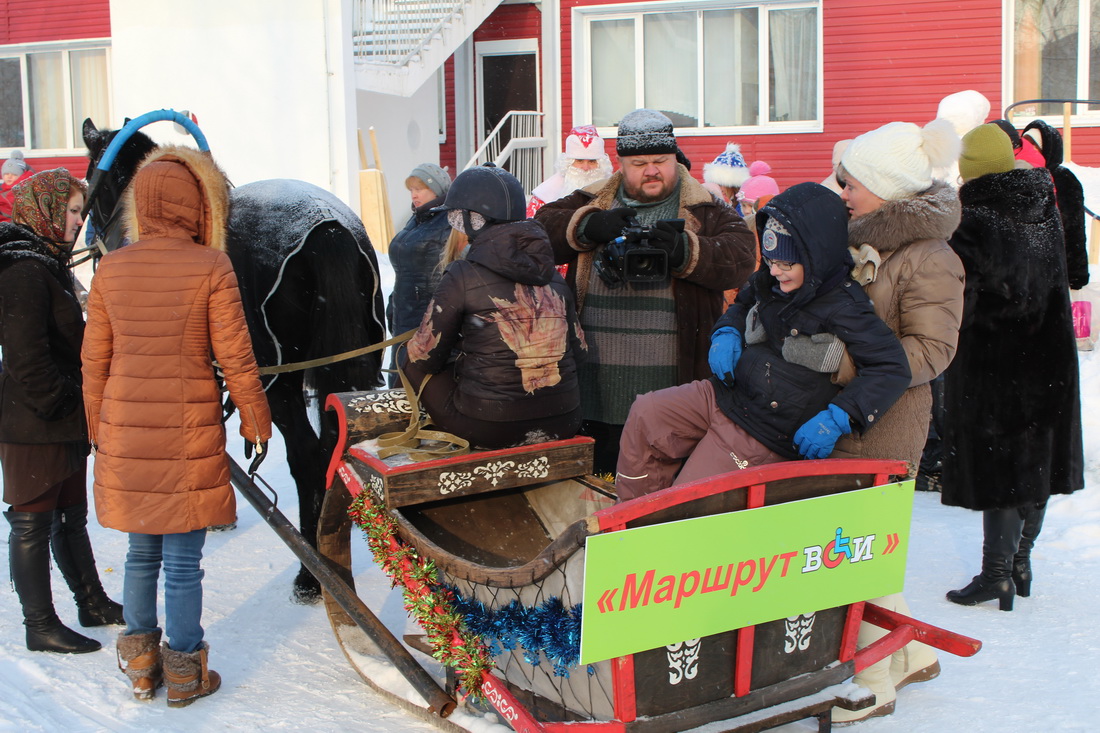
[448, 587, 592, 677]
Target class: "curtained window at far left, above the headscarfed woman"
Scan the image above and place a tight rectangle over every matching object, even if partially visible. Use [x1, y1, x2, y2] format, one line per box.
[0, 41, 111, 154]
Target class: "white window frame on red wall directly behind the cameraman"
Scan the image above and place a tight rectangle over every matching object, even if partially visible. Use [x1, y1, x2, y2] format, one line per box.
[572, 0, 825, 136]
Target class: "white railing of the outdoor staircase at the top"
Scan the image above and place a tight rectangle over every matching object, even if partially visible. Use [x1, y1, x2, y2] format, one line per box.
[352, 0, 466, 66]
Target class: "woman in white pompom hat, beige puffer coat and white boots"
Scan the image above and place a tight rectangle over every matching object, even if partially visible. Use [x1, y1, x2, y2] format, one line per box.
[818, 119, 964, 723]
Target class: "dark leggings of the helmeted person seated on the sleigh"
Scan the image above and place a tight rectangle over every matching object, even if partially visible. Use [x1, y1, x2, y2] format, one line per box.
[404, 363, 581, 449]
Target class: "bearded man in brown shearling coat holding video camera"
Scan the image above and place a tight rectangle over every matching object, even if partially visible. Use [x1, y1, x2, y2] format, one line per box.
[535, 109, 756, 473]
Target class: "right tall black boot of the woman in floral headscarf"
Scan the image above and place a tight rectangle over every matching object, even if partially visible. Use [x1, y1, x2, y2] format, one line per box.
[50, 503, 125, 627]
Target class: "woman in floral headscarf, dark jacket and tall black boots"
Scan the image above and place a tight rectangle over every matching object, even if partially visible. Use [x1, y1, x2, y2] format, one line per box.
[0, 168, 122, 654]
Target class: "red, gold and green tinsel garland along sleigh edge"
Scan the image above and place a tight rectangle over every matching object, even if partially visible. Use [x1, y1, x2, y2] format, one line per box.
[348, 491, 494, 700]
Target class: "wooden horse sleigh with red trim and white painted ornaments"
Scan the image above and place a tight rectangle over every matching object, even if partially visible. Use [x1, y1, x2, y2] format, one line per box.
[270, 391, 981, 733]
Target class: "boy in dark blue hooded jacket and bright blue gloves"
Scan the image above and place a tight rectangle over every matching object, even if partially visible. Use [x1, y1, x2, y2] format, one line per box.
[615, 183, 911, 501]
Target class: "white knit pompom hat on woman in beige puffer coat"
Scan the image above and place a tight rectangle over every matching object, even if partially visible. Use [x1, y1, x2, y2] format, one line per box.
[840, 118, 961, 200]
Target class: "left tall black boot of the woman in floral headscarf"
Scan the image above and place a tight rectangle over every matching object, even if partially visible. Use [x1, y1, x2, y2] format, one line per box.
[4, 512, 102, 654]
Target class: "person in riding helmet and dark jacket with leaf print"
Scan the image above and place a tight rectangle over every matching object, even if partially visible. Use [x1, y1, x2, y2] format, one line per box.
[405, 166, 586, 448]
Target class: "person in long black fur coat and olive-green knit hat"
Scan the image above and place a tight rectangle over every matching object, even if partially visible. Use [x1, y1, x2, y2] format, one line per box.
[943, 124, 1085, 611]
